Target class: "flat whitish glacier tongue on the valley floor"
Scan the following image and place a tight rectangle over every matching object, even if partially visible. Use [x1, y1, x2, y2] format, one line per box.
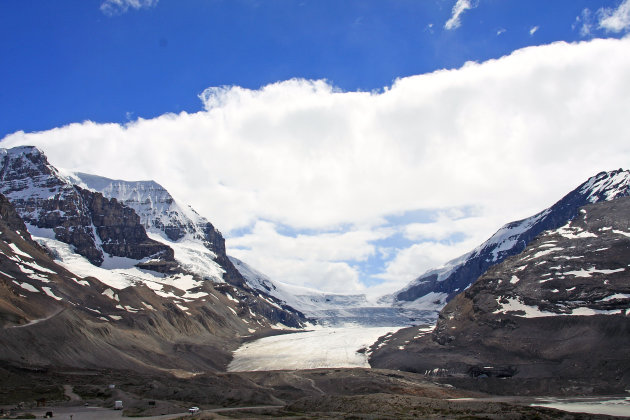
[228, 327, 402, 372]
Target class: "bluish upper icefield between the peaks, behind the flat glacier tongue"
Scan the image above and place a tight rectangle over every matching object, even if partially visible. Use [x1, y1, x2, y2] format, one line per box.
[230, 257, 434, 327]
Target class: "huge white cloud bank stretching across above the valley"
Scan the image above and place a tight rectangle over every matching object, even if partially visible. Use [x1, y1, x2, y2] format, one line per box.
[0, 39, 630, 292]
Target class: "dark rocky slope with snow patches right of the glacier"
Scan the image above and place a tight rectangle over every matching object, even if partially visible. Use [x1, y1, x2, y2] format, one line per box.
[370, 196, 630, 394]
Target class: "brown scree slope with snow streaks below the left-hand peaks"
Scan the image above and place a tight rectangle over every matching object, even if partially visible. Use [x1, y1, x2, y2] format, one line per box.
[0, 189, 262, 370]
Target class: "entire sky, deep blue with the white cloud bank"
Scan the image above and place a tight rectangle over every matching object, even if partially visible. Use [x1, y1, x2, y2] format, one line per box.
[0, 0, 630, 294]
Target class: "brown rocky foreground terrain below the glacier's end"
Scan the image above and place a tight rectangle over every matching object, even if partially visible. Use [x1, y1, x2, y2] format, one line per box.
[0, 364, 624, 420]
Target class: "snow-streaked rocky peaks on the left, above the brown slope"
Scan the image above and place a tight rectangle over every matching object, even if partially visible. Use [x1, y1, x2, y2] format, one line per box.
[0, 147, 304, 331]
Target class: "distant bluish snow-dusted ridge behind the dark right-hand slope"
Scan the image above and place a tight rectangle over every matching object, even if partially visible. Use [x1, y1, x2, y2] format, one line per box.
[390, 169, 630, 310]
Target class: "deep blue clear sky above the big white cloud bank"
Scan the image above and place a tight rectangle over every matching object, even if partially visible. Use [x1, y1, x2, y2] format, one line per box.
[0, 0, 621, 136]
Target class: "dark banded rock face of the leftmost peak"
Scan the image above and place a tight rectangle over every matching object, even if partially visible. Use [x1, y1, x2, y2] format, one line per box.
[0, 147, 176, 272]
